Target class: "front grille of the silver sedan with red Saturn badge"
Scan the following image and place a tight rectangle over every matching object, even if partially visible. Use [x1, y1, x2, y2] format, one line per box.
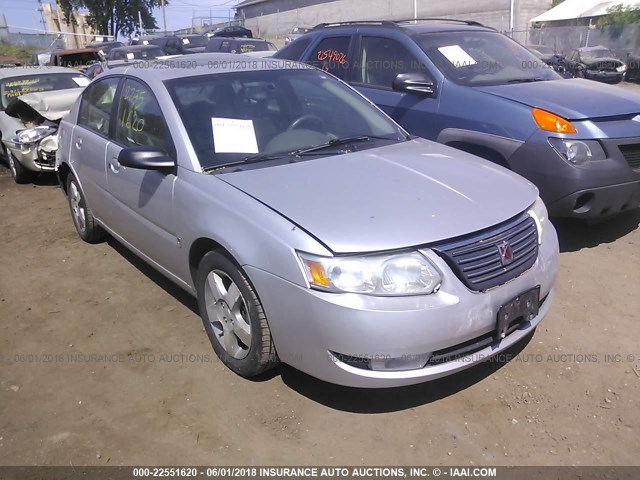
[432, 214, 538, 291]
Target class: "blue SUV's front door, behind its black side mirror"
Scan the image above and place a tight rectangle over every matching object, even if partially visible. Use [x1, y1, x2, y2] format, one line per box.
[350, 35, 441, 139]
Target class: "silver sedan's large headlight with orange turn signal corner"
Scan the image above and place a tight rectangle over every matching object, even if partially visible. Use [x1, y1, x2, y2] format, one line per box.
[298, 252, 442, 296]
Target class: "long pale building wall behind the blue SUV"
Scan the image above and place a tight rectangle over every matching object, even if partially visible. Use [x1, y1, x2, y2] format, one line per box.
[236, 0, 553, 38]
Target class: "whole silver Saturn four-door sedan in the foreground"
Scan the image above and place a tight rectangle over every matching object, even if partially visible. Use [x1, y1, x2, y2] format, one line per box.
[57, 54, 558, 387]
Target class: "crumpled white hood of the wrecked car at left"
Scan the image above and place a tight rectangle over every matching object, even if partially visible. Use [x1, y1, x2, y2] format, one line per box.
[6, 88, 84, 122]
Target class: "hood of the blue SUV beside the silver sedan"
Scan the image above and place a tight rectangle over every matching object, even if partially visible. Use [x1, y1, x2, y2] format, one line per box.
[475, 79, 640, 120]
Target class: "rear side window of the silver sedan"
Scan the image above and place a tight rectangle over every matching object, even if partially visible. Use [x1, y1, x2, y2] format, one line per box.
[78, 77, 120, 137]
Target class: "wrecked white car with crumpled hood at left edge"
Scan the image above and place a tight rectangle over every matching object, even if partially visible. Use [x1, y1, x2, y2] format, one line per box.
[0, 67, 89, 183]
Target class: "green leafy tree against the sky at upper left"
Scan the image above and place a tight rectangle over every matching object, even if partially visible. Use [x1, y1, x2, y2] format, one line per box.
[58, 0, 168, 37]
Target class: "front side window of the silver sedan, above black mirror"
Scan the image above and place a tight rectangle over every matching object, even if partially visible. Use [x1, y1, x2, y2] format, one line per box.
[115, 79, 169, 150]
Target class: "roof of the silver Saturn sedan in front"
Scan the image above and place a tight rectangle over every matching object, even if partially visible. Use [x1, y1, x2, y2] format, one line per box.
[112, 53, 314, 81]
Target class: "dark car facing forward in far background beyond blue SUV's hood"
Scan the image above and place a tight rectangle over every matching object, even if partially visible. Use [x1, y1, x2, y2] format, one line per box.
[567, 46, 627, 83]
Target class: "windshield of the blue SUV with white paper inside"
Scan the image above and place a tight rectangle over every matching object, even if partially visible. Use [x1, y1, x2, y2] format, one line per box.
[415, 31, 561, 86]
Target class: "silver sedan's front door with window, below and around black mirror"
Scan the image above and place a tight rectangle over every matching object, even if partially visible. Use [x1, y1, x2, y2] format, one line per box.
[106, 78, 179, 273]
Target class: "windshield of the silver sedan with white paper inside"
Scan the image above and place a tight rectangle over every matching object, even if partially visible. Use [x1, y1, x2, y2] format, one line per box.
[167, 69, 406, 168]
